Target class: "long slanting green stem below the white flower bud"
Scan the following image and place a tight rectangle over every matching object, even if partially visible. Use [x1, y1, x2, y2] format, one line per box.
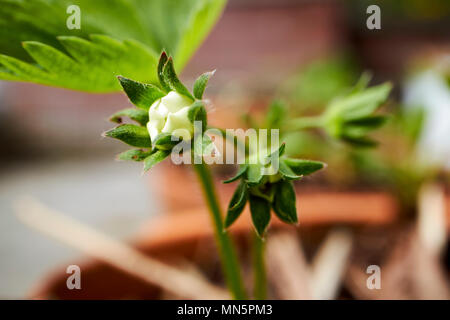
[193, 163, 246, 300]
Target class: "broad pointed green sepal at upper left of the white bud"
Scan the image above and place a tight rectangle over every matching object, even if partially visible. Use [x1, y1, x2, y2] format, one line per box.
[118, 76, 165, 110]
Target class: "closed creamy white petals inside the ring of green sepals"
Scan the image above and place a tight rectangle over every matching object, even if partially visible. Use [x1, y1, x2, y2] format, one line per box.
[147, 91, 194, 141]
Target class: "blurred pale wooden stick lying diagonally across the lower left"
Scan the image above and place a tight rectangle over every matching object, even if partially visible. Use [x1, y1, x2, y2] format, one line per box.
[15, 198, 230, 299]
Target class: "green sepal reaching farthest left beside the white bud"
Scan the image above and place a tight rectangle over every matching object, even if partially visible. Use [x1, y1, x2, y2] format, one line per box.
[104, 124, 151, 148]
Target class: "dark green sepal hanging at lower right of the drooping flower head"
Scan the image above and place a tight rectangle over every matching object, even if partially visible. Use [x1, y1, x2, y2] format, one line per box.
[272, 180, 298, 223]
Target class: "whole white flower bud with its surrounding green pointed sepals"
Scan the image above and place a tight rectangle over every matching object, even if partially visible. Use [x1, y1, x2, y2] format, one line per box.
[104, 52, 214, 171]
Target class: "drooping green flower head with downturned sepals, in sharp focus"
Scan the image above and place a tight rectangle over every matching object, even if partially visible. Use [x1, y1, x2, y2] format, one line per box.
[224, 144, 325, 237]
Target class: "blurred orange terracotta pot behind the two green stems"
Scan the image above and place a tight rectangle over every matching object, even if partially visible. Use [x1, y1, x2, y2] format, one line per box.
[30, 193, 397, 299]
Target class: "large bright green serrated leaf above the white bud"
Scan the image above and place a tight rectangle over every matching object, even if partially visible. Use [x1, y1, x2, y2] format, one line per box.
[0, 0, 225, 92]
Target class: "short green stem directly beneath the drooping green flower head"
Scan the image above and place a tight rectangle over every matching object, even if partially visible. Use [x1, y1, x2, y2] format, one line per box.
[252, 232, 267, 300]
